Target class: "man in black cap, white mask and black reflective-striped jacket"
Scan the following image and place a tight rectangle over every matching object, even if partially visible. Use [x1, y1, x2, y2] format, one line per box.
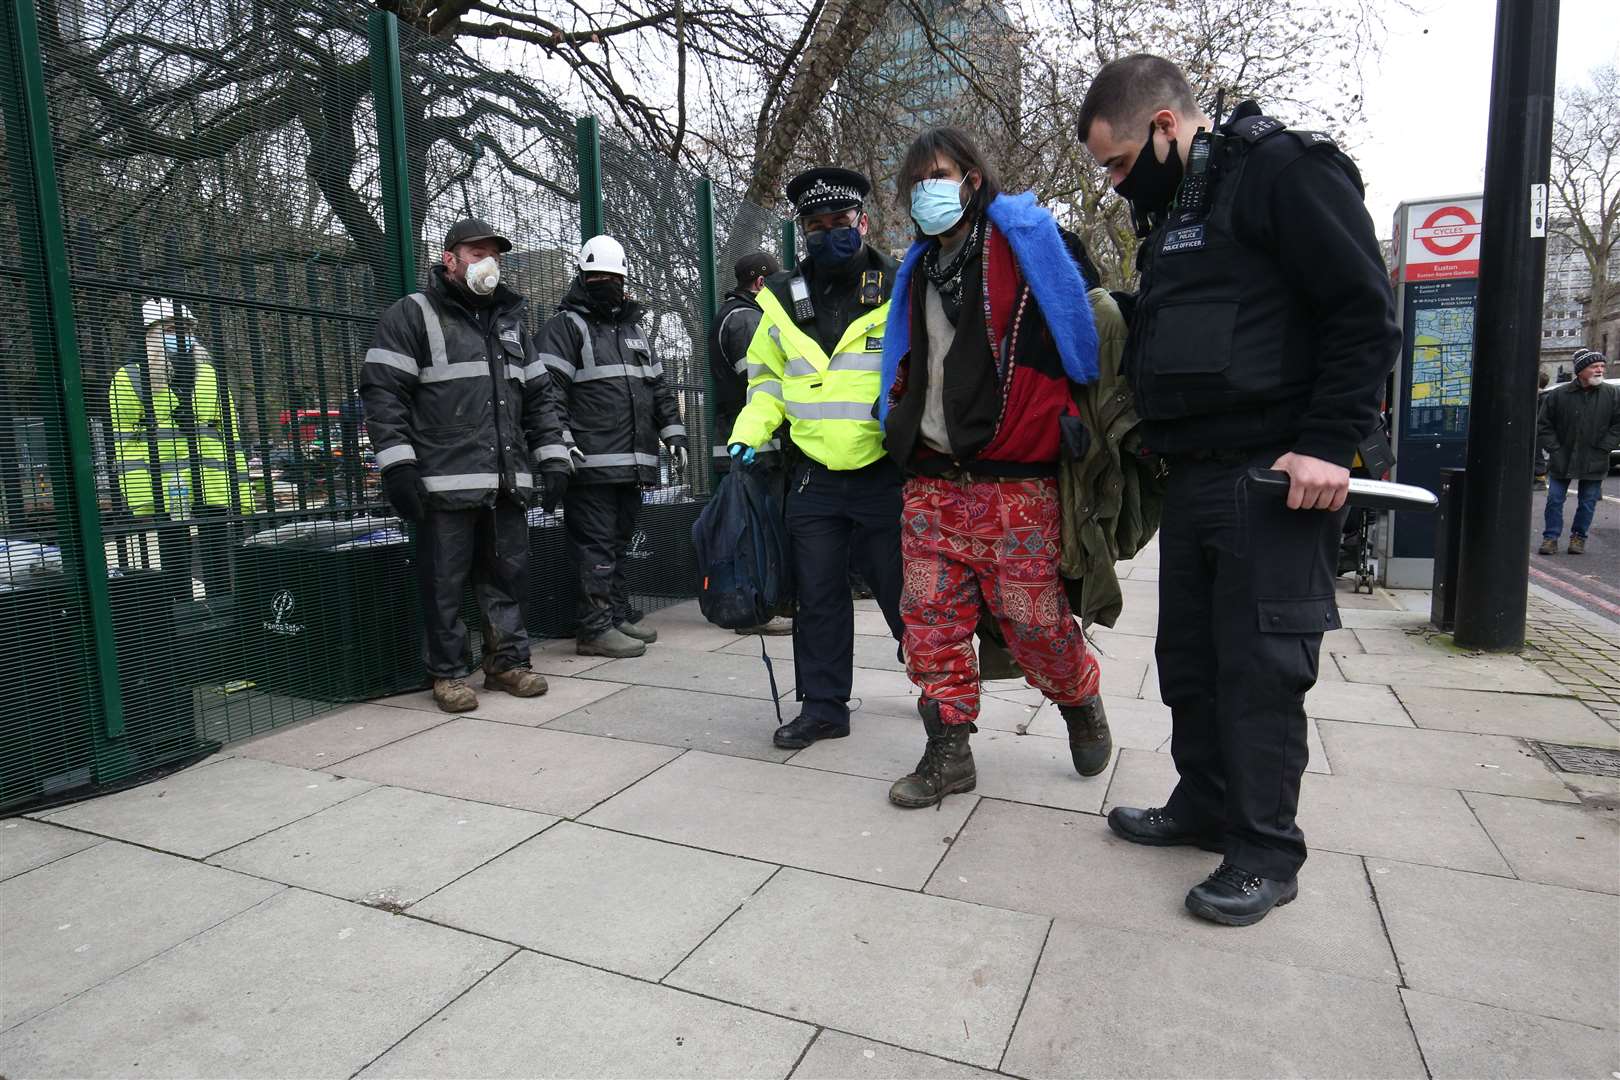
[360, 219, 570, 712]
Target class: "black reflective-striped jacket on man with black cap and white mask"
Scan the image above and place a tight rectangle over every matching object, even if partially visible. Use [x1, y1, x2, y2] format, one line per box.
[360, 267, 569, 510]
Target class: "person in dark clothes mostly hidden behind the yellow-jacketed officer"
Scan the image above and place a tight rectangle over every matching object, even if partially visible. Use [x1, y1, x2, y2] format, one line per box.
[710, 251, 794, 635]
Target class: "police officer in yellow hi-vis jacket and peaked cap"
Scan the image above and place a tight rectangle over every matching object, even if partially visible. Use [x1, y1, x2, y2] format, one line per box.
[726, 168, 902, 750]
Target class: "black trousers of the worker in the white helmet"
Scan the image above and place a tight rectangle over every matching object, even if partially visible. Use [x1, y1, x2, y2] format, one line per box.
[562, 484, 642, 641]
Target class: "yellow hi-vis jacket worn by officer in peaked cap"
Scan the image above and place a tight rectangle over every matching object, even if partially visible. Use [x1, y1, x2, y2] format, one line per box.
[727, 270, 889, 470]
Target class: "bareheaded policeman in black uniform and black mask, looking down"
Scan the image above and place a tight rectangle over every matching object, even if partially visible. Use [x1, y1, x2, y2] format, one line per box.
[1079, 55, 1400, 926]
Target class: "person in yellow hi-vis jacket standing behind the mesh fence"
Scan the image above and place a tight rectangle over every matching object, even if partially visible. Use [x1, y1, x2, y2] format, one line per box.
[107, 300, 253, 599]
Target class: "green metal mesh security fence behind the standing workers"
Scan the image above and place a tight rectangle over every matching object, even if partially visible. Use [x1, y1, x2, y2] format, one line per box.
[0, 0, 779, 810]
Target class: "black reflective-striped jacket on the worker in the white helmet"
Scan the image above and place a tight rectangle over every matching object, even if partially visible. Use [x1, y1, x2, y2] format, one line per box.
[538, 277, 687, 484]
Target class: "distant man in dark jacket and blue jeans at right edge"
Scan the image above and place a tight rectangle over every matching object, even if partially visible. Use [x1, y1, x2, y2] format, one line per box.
[1536, 348, 1620, 555]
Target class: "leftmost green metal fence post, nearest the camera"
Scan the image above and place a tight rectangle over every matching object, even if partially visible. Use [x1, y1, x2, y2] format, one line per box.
[5, 0, 123, 738]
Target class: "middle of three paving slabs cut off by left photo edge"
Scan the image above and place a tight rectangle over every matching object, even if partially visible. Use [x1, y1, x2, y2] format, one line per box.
[0, 842, 280, 1036]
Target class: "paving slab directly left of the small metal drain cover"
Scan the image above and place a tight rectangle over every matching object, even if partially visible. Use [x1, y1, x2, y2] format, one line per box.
[1319, 721, 1575, 803]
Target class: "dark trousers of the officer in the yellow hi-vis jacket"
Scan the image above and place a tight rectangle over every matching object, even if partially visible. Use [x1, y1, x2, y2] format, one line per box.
[787, 458, 904, 721]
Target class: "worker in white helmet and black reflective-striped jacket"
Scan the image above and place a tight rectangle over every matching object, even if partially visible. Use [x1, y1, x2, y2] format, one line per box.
[539, 236, 687, 657]
